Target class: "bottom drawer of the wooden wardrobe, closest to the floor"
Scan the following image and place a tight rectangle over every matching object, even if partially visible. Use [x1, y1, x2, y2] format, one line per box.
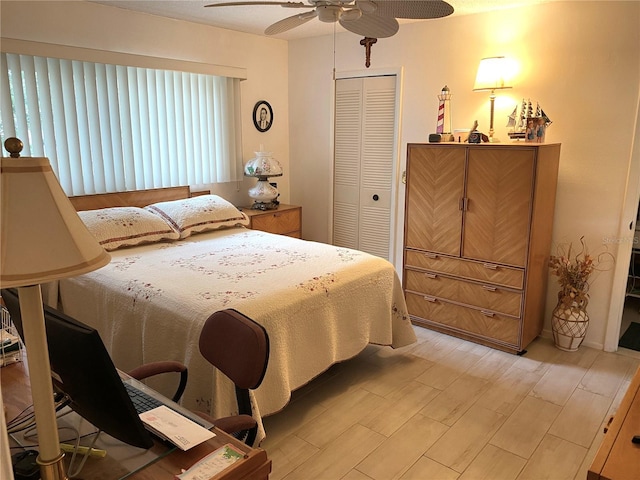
[405, 292, 520, 348]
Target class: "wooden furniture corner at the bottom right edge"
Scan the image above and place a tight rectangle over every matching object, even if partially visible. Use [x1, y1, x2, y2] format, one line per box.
[587, 368, 640, 480]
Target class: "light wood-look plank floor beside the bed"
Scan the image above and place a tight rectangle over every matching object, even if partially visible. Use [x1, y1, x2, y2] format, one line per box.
[262, 327, 640, 480]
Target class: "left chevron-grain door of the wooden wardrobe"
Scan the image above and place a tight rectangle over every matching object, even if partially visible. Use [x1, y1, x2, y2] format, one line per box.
[405, 145, 466, 256]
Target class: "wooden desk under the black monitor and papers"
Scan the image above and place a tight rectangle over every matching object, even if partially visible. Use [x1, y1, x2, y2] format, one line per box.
[0, 362, 271, 480]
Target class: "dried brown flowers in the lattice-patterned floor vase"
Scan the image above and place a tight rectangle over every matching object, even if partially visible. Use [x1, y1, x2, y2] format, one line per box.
[549, 236, 614, 308]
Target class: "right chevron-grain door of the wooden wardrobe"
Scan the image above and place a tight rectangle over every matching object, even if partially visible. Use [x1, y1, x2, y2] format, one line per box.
[462, 147, 535, 267]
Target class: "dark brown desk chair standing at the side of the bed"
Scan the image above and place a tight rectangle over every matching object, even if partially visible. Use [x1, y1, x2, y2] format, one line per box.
[196, 309, 269, 446]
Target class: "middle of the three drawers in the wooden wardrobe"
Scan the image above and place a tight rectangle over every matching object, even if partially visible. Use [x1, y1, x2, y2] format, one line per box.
[405, 269, 522, 317]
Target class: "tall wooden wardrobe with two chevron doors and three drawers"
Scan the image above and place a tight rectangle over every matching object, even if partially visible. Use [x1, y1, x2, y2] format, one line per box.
[403, 143, 560, 353]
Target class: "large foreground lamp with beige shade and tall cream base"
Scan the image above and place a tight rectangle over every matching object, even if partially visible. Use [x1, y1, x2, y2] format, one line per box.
[0, 138, 111, 480]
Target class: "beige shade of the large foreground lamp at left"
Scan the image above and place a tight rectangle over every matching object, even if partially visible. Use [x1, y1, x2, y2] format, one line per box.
[0, 157, 111, 288]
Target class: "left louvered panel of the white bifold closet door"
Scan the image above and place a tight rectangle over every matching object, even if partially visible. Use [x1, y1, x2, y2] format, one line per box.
[333, 78, 363, 249]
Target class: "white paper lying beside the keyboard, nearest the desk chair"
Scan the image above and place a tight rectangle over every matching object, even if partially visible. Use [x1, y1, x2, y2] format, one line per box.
[140, 405, 215, 450]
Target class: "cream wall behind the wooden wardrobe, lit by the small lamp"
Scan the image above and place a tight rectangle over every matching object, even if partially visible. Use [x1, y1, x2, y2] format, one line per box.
[289, 1, 640, 348]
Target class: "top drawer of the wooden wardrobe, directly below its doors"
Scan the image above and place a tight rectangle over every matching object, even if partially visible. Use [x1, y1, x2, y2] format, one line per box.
[405, 250, 524, 289]
